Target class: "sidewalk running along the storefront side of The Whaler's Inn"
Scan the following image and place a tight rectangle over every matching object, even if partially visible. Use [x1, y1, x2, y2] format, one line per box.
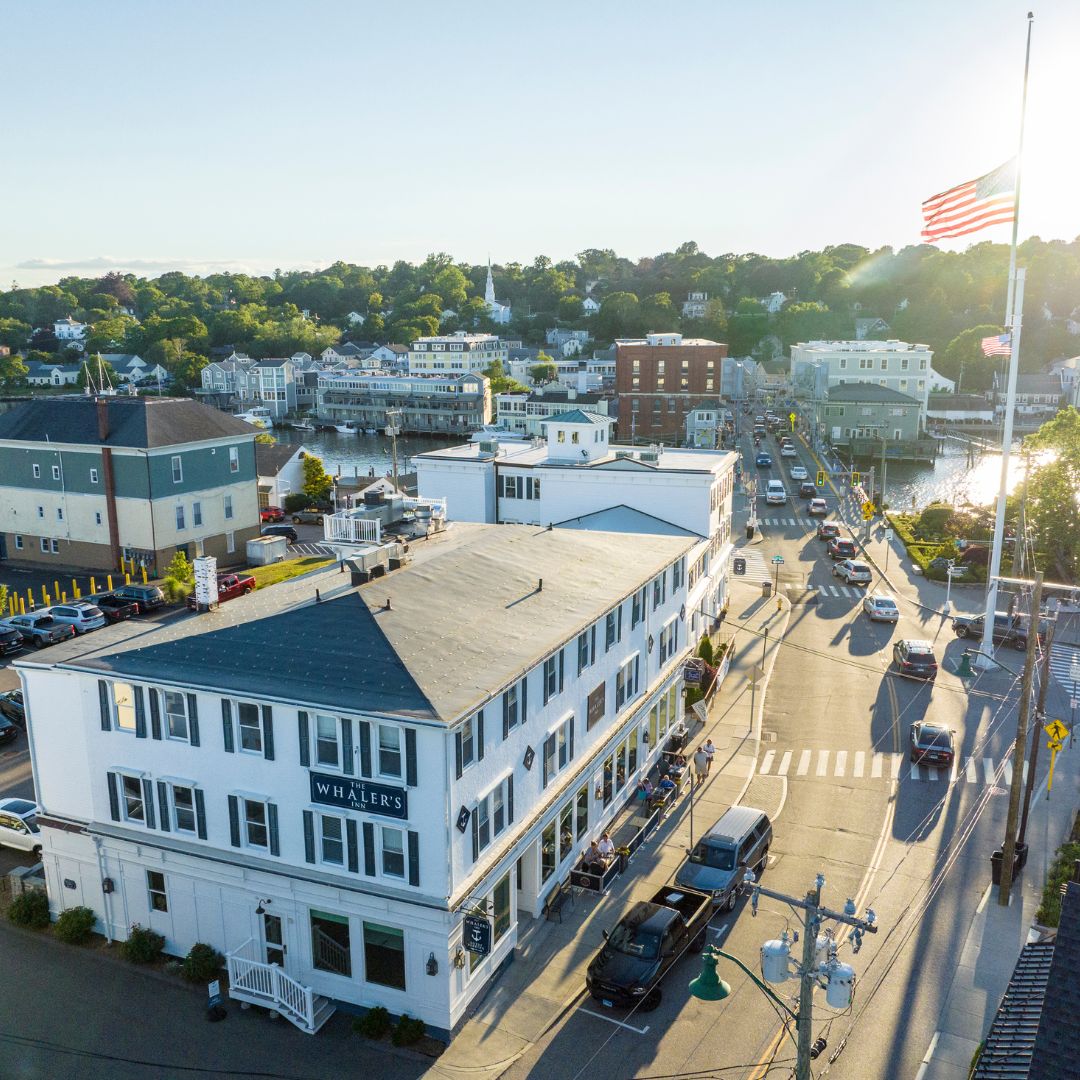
[428, 580, 789, 1078]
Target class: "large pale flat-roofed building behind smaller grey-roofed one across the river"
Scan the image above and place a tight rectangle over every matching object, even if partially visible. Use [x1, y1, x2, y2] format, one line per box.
[791, 341, 934, 428]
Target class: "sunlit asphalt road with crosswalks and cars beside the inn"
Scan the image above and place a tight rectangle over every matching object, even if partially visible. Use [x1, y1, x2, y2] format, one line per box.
[507, 419, 1062, 1080]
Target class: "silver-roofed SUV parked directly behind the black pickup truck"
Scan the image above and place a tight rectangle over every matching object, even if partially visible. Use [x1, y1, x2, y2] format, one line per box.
[675, 807, 772, 912]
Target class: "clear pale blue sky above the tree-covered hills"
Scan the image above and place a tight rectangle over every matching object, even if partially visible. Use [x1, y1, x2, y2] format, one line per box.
[0, 0, 1080, 286]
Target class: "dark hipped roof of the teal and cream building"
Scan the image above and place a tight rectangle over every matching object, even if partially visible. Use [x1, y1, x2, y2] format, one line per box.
[0, 394, 259, 449]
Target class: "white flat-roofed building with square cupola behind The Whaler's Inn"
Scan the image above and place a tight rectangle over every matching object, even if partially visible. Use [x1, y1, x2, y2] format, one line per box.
[413, 409, 738, 638]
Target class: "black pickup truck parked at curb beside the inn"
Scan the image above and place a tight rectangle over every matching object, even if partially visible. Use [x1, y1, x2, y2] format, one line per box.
[585, 885, 713, 1012]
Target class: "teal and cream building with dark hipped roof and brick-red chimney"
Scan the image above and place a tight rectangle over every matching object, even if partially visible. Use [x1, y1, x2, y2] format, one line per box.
[0, 394, 259, 577]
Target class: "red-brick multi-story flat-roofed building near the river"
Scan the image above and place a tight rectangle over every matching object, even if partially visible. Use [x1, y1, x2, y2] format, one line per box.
[616, 334, 728, 441]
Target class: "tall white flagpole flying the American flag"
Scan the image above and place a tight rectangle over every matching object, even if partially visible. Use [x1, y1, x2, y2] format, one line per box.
[975, 12, 1035, 667]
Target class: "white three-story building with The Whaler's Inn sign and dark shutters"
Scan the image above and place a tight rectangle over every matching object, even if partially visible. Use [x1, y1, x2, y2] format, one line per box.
[18, 524, 693, 1038]
